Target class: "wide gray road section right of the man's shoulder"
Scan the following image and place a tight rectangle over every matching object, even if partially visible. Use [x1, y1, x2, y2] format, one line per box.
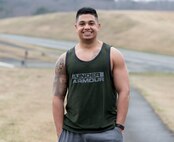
[119, 49, 174, 72]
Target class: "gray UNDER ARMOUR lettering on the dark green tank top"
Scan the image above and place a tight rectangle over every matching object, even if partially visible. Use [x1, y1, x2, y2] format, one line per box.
[72, 72, 104, 84]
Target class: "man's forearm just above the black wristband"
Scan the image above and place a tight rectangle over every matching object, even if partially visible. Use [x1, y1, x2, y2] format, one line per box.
[116, 91, 129, 125]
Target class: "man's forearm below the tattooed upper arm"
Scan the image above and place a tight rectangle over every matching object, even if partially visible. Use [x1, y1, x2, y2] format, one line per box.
[52, 96, 64, 136]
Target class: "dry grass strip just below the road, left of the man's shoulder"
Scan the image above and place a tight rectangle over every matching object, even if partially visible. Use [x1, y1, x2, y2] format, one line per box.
[0, 39, 64, 62]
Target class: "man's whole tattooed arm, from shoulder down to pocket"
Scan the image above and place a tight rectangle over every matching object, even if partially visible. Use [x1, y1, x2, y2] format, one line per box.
[52, 53, 67, 137]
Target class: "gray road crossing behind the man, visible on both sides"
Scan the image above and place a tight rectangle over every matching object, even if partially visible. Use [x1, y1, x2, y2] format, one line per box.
[0, 34, 174, 72]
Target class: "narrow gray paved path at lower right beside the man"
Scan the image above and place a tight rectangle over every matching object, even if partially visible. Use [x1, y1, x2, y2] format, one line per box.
[125, 88, 174, 142]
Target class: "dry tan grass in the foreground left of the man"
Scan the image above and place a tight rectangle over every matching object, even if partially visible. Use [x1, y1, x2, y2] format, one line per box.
[0, 68, 56, 142]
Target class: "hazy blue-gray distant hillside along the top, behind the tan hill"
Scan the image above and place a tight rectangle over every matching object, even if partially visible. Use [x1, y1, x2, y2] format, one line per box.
[0, 0, 174, 18]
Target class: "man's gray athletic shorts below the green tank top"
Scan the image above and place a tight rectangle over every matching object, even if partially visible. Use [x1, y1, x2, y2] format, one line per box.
[58, 127, 123, 142]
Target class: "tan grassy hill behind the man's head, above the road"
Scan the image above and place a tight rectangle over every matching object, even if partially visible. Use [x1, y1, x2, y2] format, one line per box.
[0, 11, 174, 55]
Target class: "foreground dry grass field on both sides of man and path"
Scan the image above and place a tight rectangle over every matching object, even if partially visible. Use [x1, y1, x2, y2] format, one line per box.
[0, 68, 174, 142]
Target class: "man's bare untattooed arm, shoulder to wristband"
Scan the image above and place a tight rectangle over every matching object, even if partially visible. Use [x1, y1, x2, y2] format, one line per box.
[111, 47, 130, 125]
